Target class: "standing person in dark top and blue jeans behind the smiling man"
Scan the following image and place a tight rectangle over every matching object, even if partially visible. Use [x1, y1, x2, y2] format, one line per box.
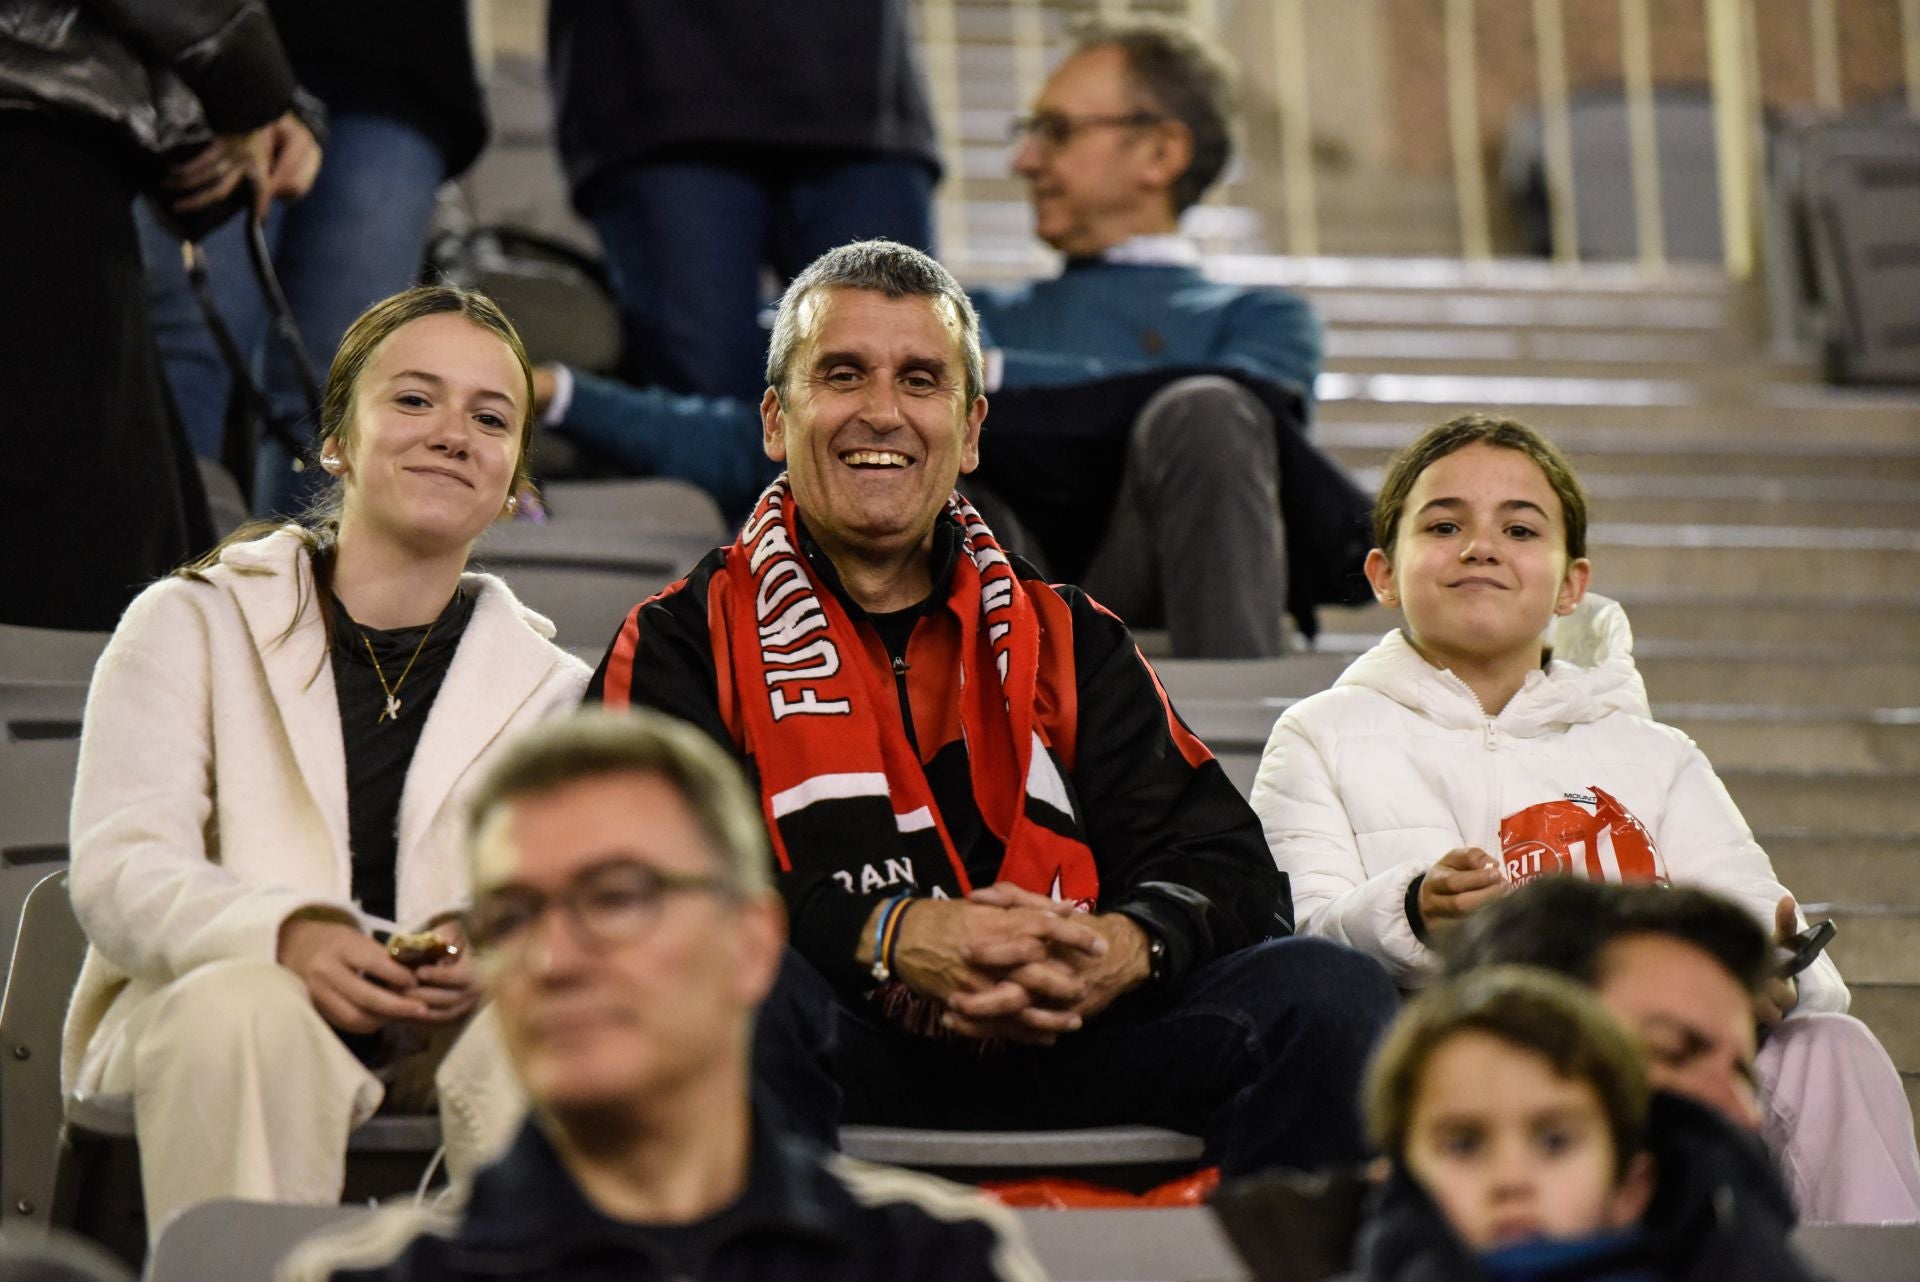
[547, 0, 941, 399]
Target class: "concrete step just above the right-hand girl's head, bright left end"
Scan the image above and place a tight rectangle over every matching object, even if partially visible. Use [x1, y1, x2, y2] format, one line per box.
[1313, 372, 1920, 445]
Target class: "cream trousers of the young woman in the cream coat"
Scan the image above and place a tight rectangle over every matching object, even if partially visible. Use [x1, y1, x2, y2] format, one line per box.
[81, 960, 518, 1240]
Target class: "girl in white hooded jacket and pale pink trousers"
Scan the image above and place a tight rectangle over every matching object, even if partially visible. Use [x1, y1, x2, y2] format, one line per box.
[1252, 415, 1920, 1221]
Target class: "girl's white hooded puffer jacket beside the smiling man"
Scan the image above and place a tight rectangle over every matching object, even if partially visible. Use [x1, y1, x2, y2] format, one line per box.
[1252, 593, 1849, 1011]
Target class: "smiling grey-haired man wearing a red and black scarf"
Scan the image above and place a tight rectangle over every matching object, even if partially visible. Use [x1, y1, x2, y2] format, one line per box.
[589, 242, 1396, 1175]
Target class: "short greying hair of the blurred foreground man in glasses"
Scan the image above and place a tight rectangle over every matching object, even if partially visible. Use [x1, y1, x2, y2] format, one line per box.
[467, 708, 774, 894]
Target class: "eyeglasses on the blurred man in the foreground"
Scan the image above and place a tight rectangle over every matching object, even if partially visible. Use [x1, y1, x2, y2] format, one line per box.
[467, 860, 735, 954]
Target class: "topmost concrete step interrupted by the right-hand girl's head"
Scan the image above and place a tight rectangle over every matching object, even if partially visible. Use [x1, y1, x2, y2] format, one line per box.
[1313, 422, 1920, 482]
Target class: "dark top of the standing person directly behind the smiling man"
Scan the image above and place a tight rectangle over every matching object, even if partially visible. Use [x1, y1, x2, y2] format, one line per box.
[547, 0, 941, 203]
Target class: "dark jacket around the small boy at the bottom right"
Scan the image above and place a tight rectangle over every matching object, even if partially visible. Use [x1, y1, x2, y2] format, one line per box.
[1354, 1094, 1820, 1282]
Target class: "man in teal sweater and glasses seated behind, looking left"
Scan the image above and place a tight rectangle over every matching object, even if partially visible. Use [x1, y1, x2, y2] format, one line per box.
[536, 19, 1321, 658]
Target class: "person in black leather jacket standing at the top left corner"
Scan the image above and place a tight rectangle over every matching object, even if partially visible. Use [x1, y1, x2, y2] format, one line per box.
[0, 0, 294, 629]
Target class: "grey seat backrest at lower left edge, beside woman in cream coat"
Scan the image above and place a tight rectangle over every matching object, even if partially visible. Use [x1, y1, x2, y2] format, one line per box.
[0, 869, 86, 1228]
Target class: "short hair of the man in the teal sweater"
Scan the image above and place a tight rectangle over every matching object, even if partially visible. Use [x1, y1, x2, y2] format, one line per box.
[1073, 15, 1238, 213]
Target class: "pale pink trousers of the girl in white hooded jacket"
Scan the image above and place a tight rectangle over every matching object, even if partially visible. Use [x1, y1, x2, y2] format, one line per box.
[1753, 1013, 1920, 1224]
